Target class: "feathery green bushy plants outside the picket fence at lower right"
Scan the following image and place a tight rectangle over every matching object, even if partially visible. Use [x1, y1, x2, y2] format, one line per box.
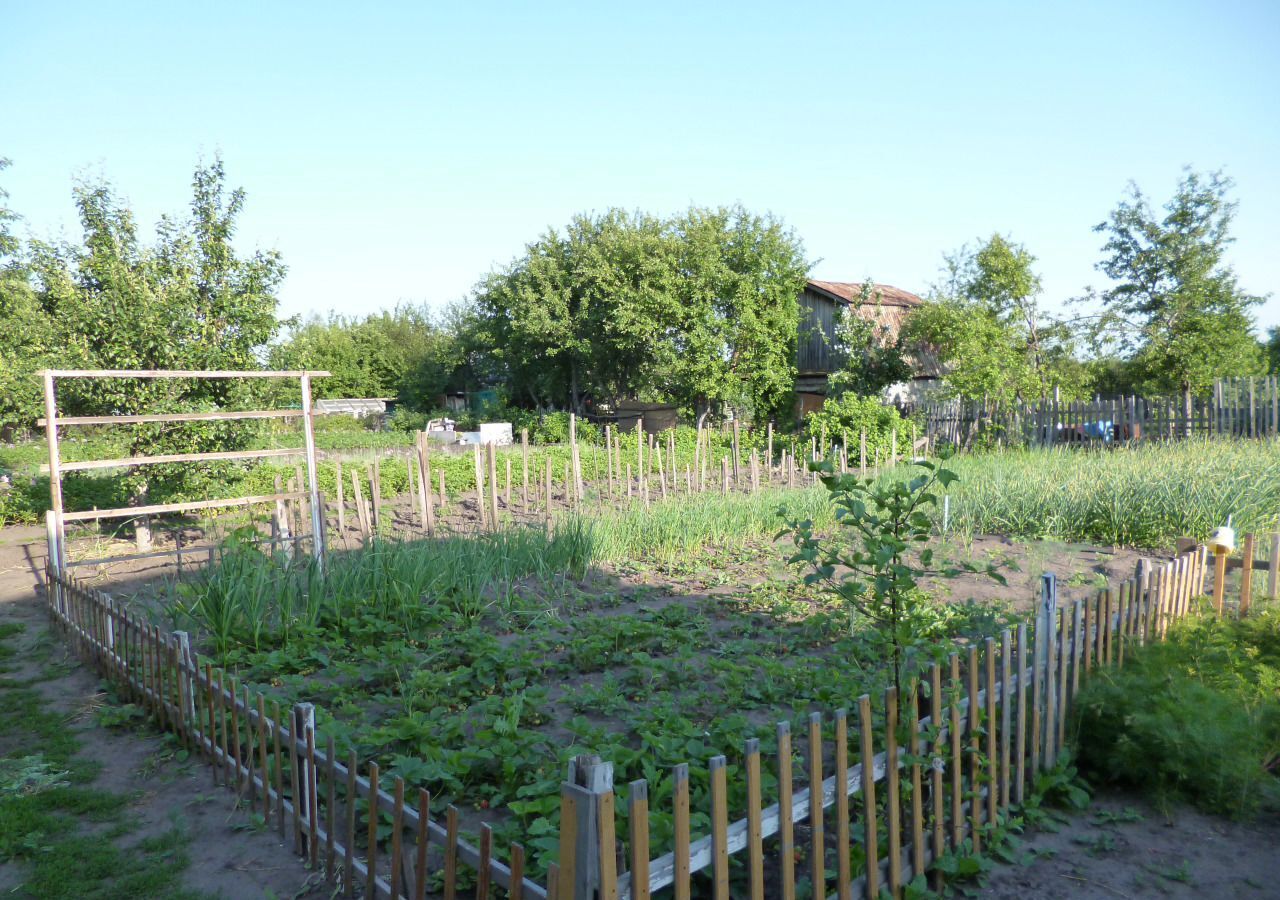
[1075, 608, 1280, 818]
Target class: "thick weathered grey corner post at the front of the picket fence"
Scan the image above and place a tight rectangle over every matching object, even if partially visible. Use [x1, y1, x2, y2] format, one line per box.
[558, 754, 617, 900]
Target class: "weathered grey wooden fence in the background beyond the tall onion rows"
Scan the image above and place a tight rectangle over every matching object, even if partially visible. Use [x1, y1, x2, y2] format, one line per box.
[909, 375, 1280, 447]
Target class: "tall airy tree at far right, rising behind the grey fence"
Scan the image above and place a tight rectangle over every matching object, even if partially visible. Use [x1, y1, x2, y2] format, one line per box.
[1093, 170, 1262, 415]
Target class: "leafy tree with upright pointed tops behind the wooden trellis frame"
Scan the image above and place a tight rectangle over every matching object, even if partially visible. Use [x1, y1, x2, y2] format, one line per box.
[31, 159, 284, 524]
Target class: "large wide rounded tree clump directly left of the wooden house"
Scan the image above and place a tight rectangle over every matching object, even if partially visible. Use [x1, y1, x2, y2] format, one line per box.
[476, 207, 808, 415]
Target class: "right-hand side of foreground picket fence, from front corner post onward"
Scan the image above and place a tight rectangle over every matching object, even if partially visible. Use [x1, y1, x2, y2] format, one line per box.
[558, 547, 1274, 900]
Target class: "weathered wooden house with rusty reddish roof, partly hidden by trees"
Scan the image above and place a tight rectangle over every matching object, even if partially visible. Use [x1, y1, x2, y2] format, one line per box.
[796, 279, 941, 417]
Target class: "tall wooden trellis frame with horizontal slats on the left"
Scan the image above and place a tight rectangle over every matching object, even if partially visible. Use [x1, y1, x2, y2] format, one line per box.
[38, 369, 329, 574]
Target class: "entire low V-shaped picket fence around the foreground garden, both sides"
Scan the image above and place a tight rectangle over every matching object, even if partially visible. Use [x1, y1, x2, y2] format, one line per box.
[40, 535, 1280, 900]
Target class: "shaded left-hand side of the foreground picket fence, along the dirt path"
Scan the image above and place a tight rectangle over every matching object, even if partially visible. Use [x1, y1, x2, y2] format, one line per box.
[46, 566, 558, 900]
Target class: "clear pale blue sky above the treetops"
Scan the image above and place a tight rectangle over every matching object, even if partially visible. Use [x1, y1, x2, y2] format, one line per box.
[0, 0, 1280, 335]
